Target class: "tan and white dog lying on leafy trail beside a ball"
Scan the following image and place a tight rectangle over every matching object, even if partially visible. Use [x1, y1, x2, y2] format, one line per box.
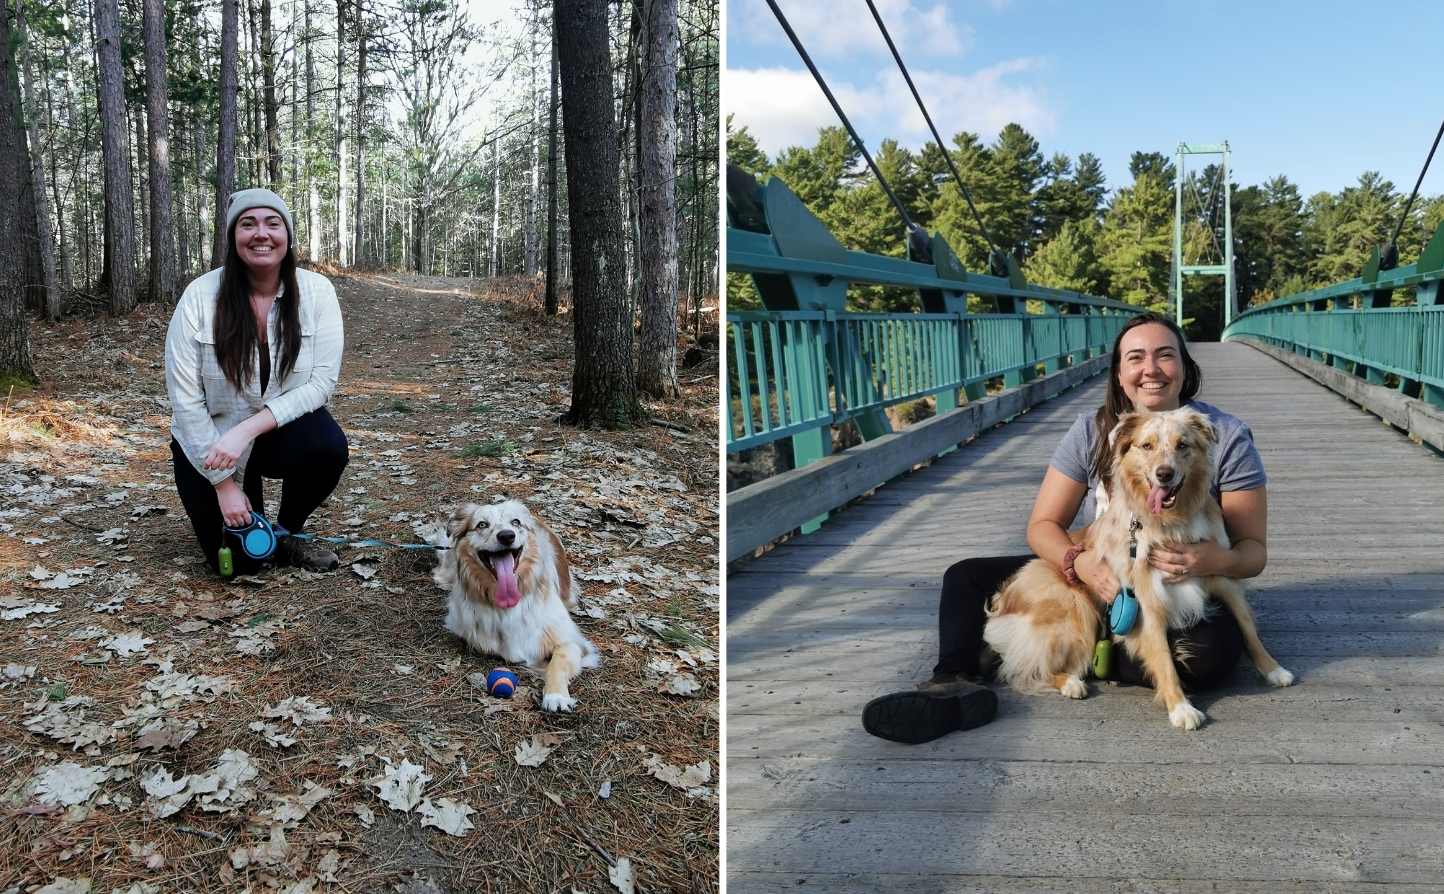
[433, 500, 601, 711]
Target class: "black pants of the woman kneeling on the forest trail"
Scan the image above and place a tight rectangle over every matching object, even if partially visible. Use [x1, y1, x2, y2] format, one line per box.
[170, 407, 351, 575]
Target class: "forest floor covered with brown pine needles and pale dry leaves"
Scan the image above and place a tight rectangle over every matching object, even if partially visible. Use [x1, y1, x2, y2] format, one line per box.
[0, 274, 721, 894]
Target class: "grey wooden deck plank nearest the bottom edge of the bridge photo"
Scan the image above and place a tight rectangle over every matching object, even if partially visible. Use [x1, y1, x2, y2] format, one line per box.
[728, 809, 1444, 884]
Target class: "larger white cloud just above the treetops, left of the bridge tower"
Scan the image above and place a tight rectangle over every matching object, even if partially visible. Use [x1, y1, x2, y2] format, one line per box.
[723, 59, 1057, 157]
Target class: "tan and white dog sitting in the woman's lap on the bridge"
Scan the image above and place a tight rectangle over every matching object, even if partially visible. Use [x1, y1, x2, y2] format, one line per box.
[983, 409, 1294, 729]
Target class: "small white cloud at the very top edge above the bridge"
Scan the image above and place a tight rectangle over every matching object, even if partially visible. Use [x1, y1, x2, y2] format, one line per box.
[728, 0, 973, 59]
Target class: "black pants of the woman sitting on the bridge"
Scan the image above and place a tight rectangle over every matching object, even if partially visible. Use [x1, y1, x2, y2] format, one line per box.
[933, 555, 1243, 689]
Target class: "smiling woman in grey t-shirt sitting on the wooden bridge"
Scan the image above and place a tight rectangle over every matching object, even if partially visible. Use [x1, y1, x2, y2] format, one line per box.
[862, 313, 1268, 744]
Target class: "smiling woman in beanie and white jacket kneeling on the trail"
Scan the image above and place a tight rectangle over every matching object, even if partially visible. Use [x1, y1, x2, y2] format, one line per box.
[166, 189, 348, 573]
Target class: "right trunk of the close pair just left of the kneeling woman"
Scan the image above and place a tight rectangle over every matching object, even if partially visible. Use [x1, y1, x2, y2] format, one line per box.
[144, 0, 176, 305]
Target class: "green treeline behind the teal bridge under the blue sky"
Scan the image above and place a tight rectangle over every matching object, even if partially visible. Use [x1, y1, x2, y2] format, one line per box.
[726, 117, 1444, 341]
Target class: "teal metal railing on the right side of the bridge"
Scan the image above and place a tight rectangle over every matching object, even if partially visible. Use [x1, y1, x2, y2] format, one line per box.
[1223, 224, 1444, 406]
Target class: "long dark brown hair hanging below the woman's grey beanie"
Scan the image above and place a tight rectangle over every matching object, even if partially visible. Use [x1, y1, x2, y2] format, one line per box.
[215, 221, 300, 391]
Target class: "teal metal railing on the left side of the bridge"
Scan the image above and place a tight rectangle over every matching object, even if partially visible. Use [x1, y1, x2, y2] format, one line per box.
[723, 265, 1139, 452]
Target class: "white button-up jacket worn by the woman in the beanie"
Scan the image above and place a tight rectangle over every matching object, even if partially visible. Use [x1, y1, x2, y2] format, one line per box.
[166, 269, 345, 484]
